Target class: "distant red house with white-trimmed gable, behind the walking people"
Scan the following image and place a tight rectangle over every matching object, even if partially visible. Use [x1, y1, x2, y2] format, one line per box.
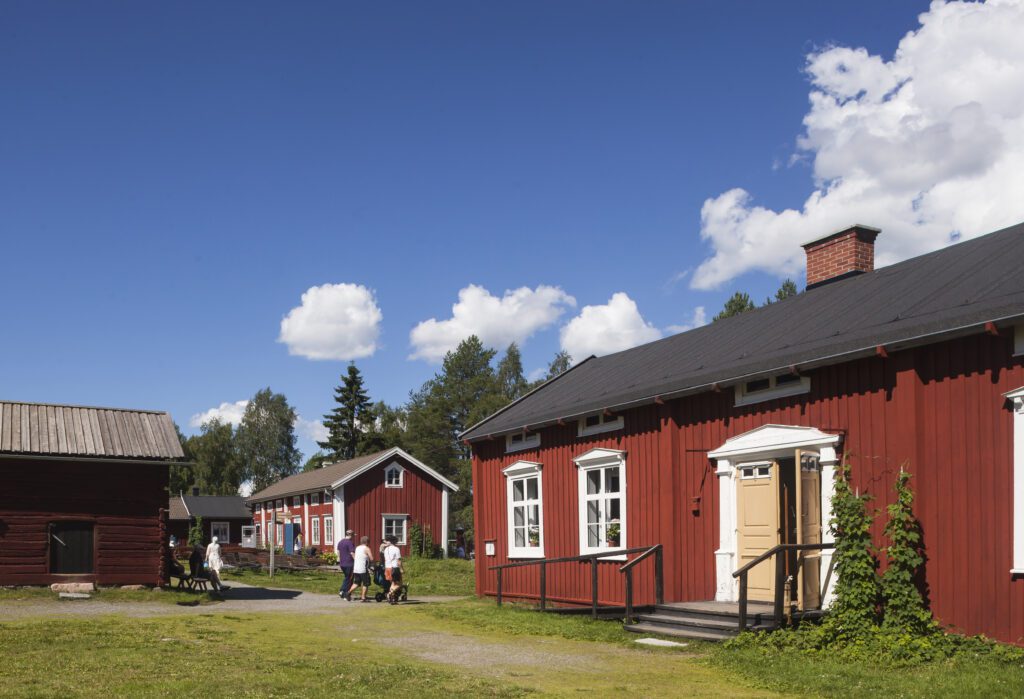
[249, 447, 459, 554]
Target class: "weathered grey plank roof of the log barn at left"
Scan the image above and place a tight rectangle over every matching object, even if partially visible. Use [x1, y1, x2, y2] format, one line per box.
[0, 401, 184, 461]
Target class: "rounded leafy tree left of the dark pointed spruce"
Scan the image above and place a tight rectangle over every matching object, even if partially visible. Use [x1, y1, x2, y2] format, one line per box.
[236, 388, 302, 492]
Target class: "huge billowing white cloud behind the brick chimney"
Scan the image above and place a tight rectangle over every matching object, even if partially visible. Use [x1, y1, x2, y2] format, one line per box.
[690, 0, 1024, 289]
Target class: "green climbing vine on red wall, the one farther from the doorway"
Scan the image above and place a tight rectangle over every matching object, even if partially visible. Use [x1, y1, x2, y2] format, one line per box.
[882, 469, 937, 637]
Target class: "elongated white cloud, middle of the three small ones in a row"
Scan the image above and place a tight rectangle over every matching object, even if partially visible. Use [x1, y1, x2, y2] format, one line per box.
[409, 285, 575, 361]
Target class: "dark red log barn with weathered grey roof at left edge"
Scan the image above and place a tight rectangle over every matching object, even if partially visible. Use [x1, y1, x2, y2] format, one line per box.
[0, 402, 184, 585]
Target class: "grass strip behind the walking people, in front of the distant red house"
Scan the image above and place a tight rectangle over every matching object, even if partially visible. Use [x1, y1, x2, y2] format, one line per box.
[221, 558, 473, 597]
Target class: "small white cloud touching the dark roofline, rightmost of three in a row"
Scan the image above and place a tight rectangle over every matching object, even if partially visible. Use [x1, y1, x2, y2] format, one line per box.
[561, 292, 662, 361]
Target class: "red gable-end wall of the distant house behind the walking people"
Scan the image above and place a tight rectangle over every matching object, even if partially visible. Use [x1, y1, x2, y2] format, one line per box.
[344, 458, 443, 556]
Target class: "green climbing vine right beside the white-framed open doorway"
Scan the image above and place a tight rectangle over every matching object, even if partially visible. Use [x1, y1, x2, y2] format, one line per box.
[823, 462, 881, 640]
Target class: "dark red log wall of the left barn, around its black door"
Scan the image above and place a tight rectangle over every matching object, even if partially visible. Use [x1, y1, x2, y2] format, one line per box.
[0, 458, 168, 584]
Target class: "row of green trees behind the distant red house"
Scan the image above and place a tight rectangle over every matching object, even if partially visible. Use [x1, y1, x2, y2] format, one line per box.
[170, 336, 572, 532]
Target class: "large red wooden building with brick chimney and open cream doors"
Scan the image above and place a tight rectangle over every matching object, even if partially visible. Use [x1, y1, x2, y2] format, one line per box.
[463, 224, 1024, 643]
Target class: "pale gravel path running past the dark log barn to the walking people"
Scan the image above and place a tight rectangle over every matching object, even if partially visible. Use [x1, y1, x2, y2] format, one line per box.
[0, 582, 459, 621]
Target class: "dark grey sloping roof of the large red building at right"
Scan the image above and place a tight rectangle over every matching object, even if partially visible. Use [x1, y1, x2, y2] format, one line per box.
[463, 223, 1024, 439]
